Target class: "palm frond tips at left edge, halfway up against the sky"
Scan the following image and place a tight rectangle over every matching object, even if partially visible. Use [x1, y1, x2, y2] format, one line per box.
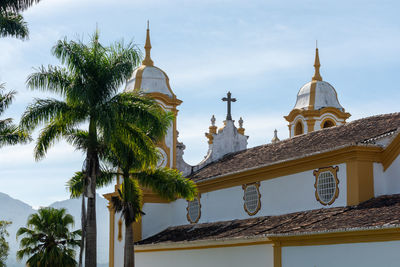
[0, 84, 30, 147]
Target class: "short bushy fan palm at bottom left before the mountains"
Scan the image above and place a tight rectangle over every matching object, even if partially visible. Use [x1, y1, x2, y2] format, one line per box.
[17, 208, 81, 267]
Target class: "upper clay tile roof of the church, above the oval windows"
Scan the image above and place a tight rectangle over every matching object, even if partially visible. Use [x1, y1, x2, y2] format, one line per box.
[189, 113, 400, 181]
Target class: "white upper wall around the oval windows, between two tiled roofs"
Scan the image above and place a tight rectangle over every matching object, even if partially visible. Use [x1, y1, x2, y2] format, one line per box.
[142, 164, 347, 238]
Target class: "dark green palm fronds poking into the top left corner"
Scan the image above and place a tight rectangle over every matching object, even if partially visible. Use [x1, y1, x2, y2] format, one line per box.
[0, 0, 40, 39]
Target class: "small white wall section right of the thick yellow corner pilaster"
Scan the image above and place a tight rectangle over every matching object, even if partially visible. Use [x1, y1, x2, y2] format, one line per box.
[374, 156, 400, 196]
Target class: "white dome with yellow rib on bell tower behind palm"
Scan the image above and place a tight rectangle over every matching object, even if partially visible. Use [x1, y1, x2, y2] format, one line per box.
[125, 65, 173, 98]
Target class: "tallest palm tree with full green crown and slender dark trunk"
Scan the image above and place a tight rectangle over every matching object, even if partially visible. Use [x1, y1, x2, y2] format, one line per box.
[21, 31, 172, 267]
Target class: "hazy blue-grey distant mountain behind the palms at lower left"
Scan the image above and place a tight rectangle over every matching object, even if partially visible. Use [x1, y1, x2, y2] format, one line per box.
[0, 193, 109, 267]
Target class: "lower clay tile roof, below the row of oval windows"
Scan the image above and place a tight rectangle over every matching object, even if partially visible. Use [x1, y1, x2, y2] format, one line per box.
[138, 194, 400, 245]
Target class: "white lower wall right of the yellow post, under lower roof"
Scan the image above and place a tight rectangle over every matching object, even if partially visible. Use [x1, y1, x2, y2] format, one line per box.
[282, 241, 400, 267]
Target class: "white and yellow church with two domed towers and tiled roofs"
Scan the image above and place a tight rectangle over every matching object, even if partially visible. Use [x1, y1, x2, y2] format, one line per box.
[104, 25, 400, 267]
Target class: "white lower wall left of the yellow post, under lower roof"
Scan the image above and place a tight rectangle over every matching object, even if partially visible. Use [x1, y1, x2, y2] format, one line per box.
[135, 245, 273, 267]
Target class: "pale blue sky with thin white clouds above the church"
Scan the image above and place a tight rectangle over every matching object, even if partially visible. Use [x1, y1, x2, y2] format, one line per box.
[0, 0, 400, 208]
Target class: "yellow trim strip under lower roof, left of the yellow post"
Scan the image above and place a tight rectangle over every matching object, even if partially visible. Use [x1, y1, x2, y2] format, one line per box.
[135, 240, 272, 253]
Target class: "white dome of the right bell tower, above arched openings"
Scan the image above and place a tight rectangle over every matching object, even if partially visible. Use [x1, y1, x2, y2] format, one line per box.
[294, 81, 344, 111]
